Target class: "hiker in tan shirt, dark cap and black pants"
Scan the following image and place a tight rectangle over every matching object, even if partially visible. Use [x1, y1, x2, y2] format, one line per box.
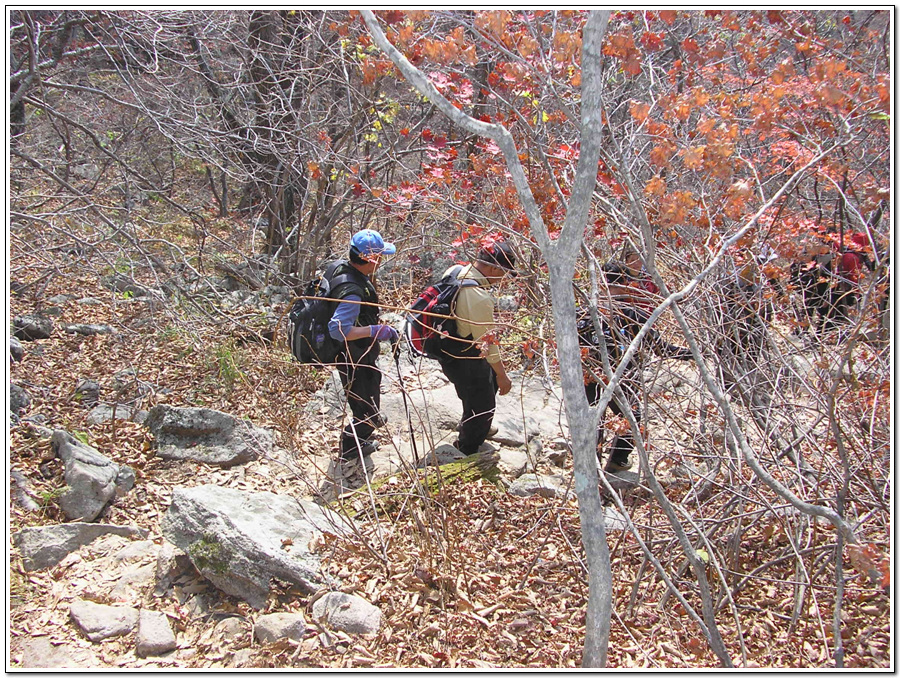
[434, 241, 516, 455]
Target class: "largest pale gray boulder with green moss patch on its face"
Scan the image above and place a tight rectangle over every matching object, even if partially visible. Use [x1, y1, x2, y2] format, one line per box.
[161, 485, 346, 609]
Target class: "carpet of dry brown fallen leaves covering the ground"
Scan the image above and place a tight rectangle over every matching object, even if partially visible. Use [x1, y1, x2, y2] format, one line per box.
[8, 227, 892, 669]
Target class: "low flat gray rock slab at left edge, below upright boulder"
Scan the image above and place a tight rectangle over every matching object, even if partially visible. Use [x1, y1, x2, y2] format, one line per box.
[13, 523, 149, 571]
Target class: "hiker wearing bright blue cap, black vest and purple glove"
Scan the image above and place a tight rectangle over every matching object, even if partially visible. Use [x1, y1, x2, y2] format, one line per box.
[328, 229, 399, 460]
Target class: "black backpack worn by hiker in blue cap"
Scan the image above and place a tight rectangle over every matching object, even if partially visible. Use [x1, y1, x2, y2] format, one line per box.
[288, 260, 359, 365]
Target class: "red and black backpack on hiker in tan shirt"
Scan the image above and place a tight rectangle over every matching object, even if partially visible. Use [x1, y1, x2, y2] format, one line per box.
[404, 264, 478, 358]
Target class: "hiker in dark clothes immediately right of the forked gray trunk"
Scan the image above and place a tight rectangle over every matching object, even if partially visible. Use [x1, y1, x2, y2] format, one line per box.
[577, 261, 692, 473]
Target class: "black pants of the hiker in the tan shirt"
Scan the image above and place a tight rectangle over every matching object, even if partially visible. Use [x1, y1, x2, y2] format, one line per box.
[438, 352, 499, 455]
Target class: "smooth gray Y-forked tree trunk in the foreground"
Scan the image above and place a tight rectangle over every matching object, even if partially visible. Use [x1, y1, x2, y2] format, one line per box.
[362, 10, 612, 668]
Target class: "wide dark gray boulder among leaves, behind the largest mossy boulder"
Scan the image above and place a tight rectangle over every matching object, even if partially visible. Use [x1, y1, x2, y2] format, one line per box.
[144, 405, 275, 468]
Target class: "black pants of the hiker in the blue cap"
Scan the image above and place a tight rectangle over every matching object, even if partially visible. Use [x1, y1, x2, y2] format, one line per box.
[335, 342, 381, 454]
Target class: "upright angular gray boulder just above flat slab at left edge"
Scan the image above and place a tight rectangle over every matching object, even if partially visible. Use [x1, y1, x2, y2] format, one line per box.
[51, 430, 135, 522]
